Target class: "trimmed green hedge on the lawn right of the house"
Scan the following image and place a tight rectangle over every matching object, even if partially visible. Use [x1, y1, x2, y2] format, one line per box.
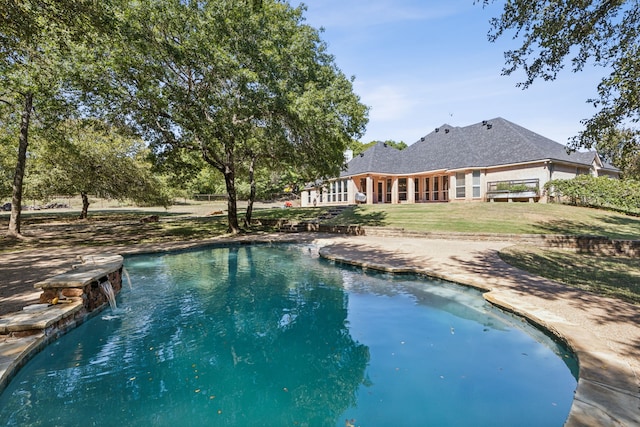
[545, 175, 640, 215]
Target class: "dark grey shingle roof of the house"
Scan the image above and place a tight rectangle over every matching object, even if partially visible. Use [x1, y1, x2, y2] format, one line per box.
[341, 117, 610, 176]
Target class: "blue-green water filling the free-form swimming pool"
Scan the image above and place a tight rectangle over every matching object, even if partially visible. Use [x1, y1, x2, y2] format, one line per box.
[0, 245, 576, 427]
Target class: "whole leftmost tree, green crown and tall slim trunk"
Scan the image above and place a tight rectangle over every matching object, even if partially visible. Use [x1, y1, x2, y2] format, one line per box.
[0, 0, 119, 237]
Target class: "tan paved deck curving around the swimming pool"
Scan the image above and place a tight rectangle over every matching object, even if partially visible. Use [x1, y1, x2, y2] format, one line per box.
[0, 233, 640, 426]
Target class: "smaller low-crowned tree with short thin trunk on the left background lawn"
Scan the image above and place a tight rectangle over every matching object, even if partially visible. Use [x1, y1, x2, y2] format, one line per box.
[28, 120, 170, 219]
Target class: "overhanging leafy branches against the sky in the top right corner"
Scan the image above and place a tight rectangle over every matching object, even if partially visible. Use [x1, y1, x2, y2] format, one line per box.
[478, 0, 640, 150]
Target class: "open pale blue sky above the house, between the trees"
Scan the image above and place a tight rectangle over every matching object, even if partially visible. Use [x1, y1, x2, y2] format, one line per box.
[290, 0, 604, 144]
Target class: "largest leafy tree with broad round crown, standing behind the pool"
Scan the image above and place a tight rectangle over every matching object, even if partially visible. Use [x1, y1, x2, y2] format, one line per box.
[107, 0, 366, 233]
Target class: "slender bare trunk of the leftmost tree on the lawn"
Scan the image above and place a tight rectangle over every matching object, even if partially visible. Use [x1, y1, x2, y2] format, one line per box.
[7, 92, 33, 237]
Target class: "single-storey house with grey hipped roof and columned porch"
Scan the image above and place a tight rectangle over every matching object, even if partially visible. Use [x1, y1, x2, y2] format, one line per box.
[301, 117, 620, 206]
